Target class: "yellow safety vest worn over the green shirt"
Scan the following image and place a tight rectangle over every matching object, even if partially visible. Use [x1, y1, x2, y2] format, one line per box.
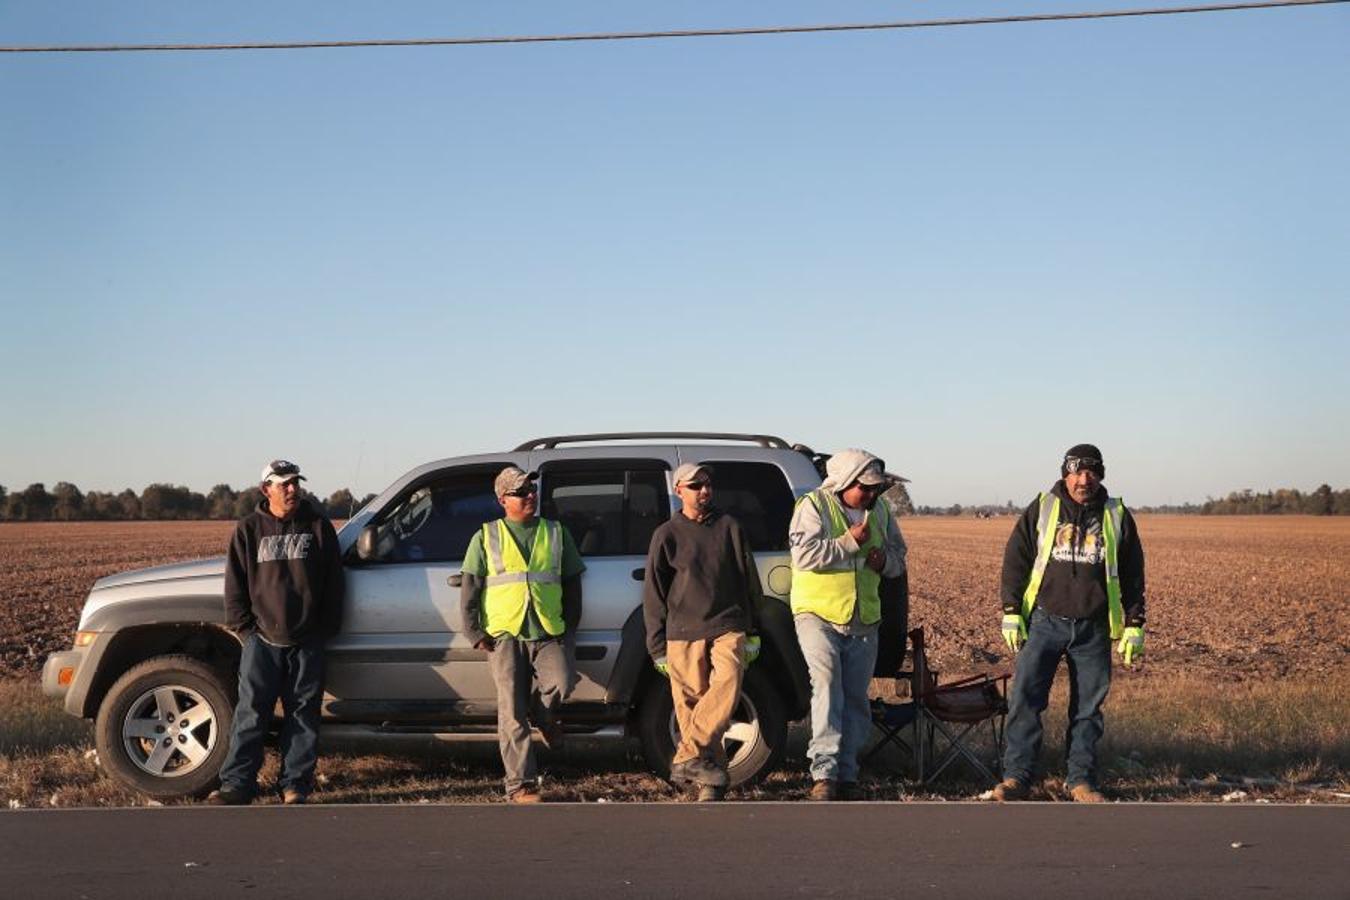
[483, 518, 564, 636]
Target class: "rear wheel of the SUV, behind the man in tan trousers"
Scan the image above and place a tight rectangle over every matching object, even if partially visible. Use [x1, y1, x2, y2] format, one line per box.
[637, 667, 787, 787]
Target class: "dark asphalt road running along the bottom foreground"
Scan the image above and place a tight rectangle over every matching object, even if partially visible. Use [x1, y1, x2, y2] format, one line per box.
[0, 803, 1350, 900]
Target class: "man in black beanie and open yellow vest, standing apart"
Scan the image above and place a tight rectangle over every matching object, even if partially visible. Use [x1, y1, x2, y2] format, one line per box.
[994, 444, 1143, 803]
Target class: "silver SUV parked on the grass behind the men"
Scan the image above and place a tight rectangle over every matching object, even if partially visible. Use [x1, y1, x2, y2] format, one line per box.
[42, 432, 822, 799]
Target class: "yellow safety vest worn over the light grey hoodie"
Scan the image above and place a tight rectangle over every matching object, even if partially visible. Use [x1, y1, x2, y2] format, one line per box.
[791, 490, 891, 625]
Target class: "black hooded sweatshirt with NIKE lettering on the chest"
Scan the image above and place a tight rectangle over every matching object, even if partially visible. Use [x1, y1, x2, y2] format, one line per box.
[225, 501, 346, 645]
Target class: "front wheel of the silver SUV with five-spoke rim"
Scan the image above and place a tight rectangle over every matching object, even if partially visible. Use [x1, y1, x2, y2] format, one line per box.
[95, 656, 235, 800]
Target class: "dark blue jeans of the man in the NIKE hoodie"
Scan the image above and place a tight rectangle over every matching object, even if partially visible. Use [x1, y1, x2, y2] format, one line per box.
[220, 634, 324, 796]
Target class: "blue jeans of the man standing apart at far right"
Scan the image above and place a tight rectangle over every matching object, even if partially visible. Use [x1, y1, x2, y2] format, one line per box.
[1003, 607, 1111, 788]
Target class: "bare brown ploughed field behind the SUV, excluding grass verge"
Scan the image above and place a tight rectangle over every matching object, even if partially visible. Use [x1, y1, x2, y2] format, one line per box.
[0, 515, 1350, 681]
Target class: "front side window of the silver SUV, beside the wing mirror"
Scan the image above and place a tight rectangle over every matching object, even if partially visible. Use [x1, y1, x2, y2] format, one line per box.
[375, 466, 502, 563]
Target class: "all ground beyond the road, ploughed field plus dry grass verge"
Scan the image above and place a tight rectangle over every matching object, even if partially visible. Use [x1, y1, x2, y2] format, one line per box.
[0, 515, 1350, 808]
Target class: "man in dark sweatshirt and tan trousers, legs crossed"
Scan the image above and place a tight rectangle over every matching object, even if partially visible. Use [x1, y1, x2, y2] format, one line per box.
[643, 463, 760, 800]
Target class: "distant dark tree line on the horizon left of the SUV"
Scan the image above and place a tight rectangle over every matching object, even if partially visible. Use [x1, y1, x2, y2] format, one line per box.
[0, 482, 375, 522]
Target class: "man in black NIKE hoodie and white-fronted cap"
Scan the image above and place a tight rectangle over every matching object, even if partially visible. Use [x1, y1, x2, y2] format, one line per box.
[209, 460, 344, 806]
